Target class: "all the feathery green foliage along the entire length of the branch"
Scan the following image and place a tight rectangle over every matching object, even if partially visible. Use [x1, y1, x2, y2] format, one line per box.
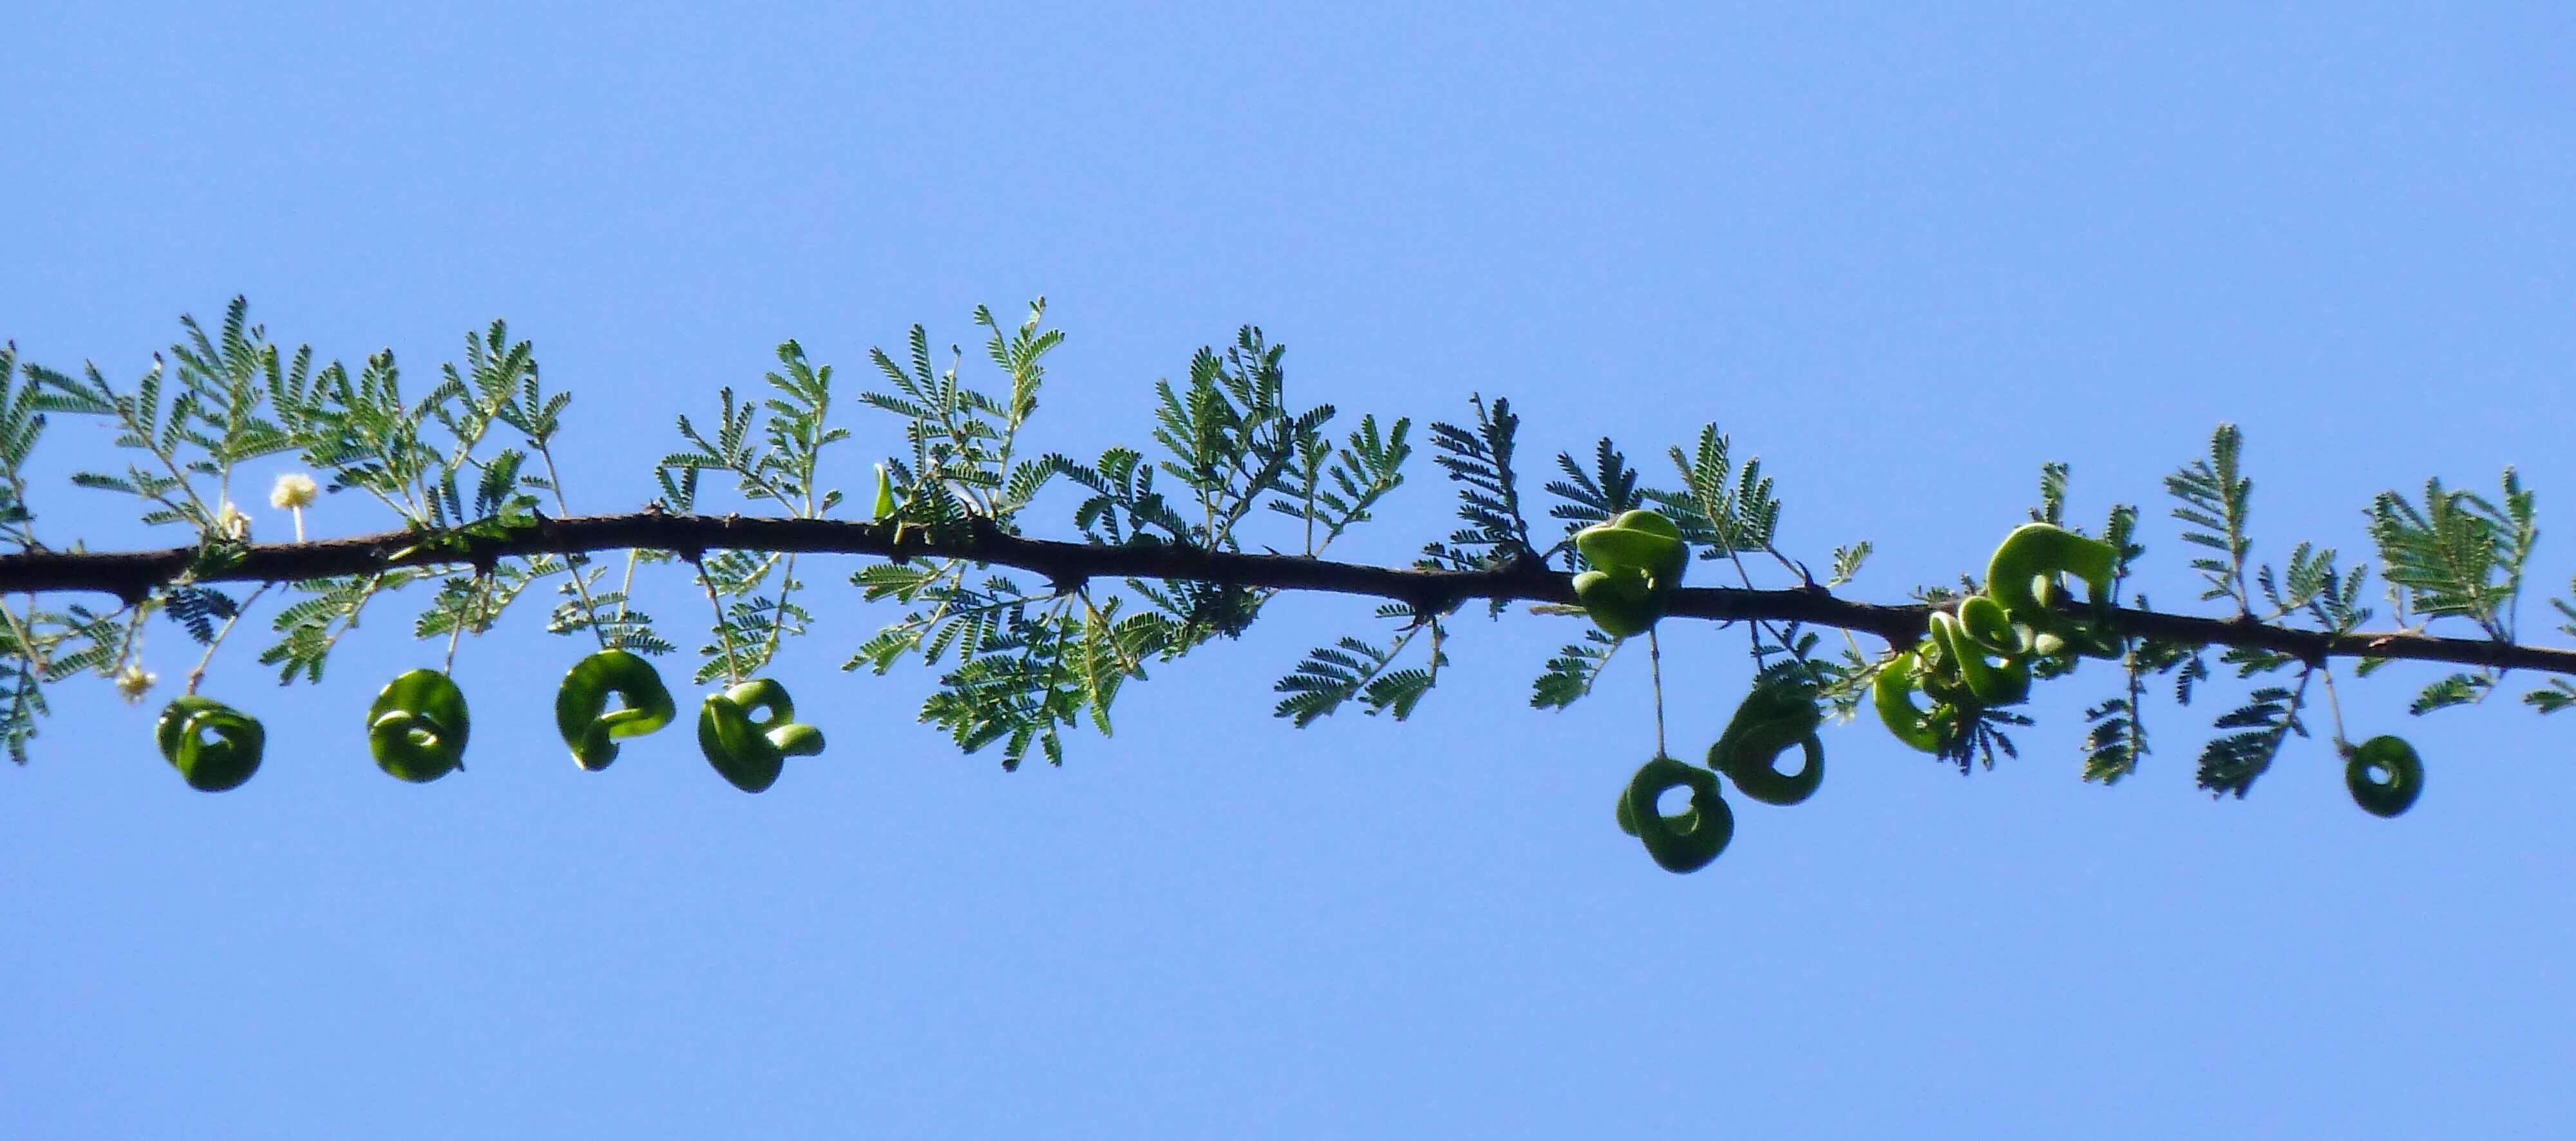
[0, 299, 2576, 845]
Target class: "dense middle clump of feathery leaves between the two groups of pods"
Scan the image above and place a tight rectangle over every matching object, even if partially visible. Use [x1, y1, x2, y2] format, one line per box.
[845, 307, 1437, 767]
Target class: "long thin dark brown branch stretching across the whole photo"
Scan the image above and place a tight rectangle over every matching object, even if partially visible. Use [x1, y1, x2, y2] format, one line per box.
[0, 510, 2576, 675]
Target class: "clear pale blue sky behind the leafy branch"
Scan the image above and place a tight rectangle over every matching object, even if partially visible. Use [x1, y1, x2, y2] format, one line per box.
[0, 3, 2576, 1138]
